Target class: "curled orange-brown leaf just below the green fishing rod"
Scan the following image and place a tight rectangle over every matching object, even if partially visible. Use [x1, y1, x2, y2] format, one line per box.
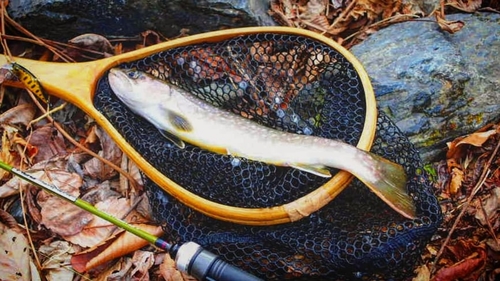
[71, 224, 163, 272]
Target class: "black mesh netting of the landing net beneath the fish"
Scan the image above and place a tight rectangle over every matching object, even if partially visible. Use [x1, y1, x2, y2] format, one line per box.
[94, 34, 441, 280]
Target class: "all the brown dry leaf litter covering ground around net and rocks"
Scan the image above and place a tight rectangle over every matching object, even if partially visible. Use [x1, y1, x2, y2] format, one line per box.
[0, 0, 500, 281]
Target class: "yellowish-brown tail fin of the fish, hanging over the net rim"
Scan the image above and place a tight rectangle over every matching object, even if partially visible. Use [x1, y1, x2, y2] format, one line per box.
[353, 152, 416, 219]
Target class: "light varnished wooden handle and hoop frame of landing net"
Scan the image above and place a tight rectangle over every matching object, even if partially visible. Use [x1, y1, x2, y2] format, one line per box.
[0, 26, 377, 225]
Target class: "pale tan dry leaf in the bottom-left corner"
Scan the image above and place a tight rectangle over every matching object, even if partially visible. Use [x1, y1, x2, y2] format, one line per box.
[0, 223, 40, 281]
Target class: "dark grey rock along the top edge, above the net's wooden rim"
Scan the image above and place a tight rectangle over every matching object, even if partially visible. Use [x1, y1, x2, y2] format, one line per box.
[8, 0, 274, 42]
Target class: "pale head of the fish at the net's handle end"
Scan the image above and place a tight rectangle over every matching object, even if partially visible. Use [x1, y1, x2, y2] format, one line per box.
[108, 68, 174, 108]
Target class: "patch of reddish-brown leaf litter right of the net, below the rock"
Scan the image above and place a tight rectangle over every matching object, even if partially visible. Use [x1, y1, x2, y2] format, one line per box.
[417, 123, 500, 281]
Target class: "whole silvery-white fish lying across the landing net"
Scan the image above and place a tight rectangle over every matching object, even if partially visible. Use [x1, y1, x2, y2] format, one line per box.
[108, 68, 416, 218]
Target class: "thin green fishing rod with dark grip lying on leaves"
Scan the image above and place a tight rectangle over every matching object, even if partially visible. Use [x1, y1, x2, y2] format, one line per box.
[0, 161, 262, 281]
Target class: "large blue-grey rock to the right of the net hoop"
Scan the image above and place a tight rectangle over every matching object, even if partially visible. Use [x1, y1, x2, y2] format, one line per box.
[351, 13, 500, 161]
